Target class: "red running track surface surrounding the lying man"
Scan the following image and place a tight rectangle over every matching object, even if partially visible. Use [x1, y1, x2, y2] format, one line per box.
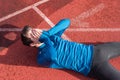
[0, 0, 120, 80]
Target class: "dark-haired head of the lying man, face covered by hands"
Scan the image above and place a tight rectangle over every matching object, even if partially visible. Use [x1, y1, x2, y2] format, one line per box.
[21, 25, 41, 47]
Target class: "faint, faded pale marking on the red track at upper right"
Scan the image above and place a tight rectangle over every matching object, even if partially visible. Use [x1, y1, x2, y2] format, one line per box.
[71, 3, 105, 27]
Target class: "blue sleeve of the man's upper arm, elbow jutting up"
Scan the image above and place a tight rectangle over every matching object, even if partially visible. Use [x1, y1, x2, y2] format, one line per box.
[48, 19, 70, 36]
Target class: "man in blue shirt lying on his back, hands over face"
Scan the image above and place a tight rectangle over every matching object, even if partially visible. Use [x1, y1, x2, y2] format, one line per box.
[21, 19, 120, 80]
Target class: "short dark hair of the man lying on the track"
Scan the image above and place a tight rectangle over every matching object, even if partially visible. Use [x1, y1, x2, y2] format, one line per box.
[21, 25, 33, 46]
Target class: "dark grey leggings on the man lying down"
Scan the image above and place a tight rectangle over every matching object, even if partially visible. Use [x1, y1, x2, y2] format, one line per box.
[90, 42, 120, 80]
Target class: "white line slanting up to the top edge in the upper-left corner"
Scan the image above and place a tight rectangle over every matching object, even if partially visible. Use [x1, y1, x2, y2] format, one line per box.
[0, 0, 49, 22]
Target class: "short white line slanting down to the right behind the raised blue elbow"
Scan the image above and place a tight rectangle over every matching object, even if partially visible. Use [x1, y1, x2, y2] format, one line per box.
[32, 6, 71, 40]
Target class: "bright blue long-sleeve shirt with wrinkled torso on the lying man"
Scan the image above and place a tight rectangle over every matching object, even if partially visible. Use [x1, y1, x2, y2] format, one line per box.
[37, 19, 93, 75]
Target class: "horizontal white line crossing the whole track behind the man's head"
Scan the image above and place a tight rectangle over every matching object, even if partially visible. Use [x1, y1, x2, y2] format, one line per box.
[0, 28, 120, 32]
